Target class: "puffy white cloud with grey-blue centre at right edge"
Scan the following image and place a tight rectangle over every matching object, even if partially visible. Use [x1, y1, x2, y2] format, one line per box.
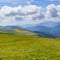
[45, 4, 60, 18]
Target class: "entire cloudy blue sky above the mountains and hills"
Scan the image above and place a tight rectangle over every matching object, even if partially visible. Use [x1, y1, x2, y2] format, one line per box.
[0, 0, 60, 26]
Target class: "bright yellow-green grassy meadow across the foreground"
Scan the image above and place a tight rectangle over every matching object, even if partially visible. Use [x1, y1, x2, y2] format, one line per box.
[0, 34, 60, 60]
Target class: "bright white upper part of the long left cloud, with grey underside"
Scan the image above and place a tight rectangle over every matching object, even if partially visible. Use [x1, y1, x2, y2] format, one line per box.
[5, 5, 41, 16]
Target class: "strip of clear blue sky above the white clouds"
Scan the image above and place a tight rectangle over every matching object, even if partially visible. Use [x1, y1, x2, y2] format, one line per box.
[0, 0, 60, 7]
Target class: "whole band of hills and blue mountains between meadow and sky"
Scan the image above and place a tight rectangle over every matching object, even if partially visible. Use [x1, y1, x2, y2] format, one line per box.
[0, 21, 60, 38]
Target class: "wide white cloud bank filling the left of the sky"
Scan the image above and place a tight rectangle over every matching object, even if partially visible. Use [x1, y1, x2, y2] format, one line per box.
[0, 5, 42, 25]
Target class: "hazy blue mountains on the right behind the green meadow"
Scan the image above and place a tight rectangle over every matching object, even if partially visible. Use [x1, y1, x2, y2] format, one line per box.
[23, 21, 60, 38]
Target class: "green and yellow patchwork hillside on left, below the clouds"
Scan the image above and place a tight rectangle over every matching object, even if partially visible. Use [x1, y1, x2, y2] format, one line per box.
[0, 26, 36, 35]
